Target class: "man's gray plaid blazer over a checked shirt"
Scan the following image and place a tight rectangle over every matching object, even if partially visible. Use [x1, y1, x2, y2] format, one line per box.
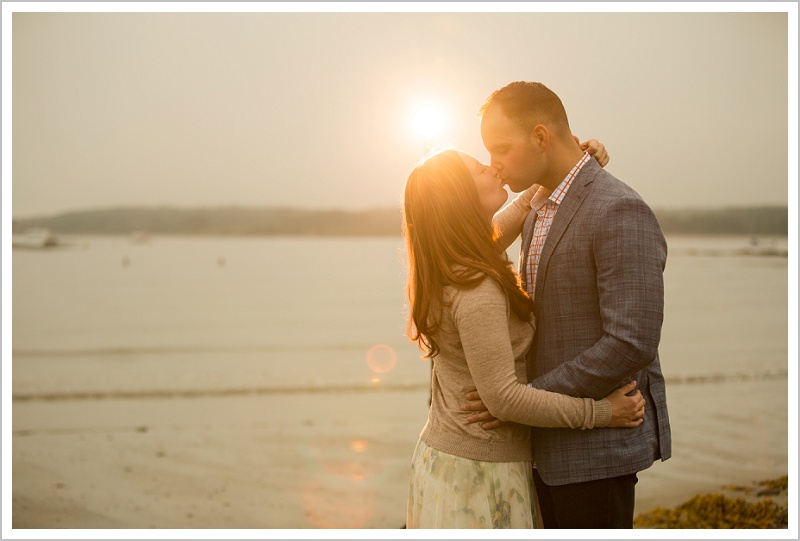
[519, 156, 672, 485]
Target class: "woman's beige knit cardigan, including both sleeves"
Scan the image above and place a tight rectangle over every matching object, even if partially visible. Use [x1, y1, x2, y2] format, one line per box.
[420, 186, 611, 462]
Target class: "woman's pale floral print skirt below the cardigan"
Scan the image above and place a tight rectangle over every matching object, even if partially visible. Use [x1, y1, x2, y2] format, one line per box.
[406, 440, 538, 528]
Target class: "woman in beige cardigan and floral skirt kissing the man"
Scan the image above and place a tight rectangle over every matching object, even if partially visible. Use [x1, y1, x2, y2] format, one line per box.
[403, 149, 644, 528]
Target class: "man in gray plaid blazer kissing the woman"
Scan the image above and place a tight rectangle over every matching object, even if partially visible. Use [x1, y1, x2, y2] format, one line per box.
[464, 82, 671, 528]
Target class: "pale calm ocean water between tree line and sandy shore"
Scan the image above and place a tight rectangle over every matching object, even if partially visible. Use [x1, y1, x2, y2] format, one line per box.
[9, 233, 789, 398]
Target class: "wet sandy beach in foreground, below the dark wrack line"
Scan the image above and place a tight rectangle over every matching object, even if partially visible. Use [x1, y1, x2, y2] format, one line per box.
[12, 377, 791, 529]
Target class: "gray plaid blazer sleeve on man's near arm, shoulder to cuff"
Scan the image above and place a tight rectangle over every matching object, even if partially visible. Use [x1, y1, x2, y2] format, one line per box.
[530, 197, 667, 398]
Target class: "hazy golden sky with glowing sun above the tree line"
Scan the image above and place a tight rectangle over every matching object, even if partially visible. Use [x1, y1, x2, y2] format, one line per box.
[3, 4, 797, 217]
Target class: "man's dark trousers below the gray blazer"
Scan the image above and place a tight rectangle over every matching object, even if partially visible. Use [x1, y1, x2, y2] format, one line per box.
[533, 468, 639, 528]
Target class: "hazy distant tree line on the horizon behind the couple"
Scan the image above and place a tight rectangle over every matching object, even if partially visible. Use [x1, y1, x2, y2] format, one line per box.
[12, 206, 789, 236]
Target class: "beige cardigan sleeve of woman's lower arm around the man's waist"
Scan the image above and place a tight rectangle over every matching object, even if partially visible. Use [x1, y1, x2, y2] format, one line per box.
[451, 278, 611, 429]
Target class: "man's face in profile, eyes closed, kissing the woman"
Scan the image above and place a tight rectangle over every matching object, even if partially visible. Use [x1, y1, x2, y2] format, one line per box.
[481, 107, 544, 192]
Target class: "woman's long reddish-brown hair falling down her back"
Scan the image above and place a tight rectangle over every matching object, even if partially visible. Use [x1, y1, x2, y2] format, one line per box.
[403, 149, 531, 358]
